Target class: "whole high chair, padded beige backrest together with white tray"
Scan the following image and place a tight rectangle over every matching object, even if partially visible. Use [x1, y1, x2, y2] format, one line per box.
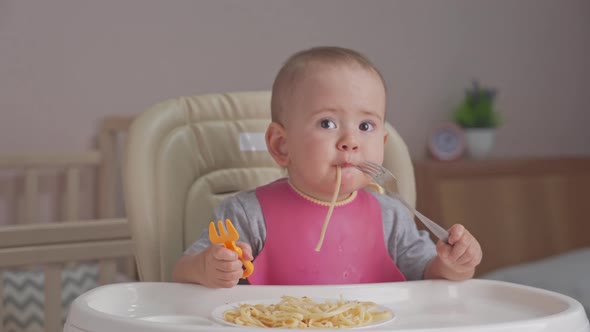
[64, 92, 590, 332]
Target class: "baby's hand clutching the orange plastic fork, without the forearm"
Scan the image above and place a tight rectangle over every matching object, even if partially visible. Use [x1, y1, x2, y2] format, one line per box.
[203, 242, 253, 288]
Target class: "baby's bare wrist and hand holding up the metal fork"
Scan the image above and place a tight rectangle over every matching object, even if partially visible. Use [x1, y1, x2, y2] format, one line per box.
[424, 224, 483, 280]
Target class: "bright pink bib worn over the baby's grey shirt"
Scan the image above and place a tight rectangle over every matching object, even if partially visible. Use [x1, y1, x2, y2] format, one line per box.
[248, 179, 405, 285]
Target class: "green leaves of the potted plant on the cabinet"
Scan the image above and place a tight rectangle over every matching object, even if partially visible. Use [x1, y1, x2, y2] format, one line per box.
[453, 80, 501, 128]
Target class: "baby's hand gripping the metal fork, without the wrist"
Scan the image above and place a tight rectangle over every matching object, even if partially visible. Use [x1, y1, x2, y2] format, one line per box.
[436, 224, 483, 279]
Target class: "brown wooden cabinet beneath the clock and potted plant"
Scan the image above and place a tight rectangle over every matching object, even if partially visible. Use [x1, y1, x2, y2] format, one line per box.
[414, 157, 590, 274]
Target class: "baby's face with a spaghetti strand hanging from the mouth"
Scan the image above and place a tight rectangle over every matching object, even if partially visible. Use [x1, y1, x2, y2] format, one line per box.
[283, 65, 386, 201]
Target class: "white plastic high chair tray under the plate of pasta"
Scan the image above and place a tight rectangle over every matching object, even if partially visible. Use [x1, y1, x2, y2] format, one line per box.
[64, 279, 590, 332]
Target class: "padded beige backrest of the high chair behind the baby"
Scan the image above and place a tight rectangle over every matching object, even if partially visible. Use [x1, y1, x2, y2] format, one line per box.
[123, 91, 416, 281]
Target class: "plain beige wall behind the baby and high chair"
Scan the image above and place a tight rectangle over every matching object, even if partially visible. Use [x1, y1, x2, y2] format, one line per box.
[0, 0, 590, 158]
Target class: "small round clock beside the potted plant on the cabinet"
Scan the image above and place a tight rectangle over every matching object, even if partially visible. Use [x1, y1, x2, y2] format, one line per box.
[428, 122, 465, 160]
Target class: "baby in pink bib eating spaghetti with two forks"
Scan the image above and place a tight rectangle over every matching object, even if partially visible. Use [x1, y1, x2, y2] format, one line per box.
[173, 47, 482, 288]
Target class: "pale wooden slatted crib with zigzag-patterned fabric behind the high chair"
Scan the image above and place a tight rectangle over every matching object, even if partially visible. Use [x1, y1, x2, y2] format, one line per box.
[0, 117, 136, 332]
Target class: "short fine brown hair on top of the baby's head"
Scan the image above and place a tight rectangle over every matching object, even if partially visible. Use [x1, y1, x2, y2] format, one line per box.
[271, 46, 386, 123]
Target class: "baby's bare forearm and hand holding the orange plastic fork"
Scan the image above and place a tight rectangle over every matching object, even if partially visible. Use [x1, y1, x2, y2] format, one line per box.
[172, 242, 253, 288]
